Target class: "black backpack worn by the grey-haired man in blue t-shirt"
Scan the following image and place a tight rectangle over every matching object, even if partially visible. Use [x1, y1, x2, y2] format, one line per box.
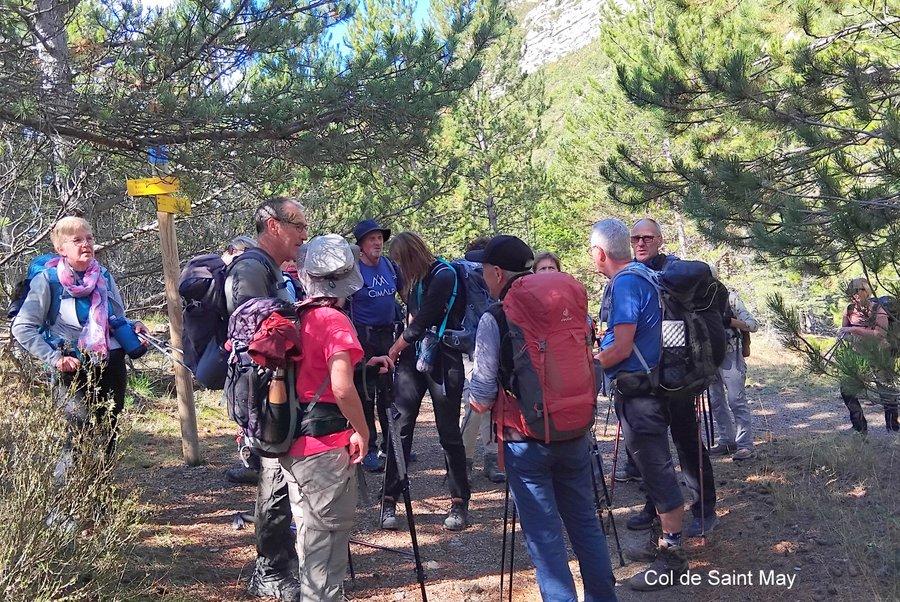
[610, 260, 728, 400]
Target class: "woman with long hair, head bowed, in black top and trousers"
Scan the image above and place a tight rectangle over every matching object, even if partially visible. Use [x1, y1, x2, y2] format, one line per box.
[381, 232, 470, 531]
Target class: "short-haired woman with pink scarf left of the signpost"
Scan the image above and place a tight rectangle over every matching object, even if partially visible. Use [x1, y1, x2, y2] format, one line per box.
[12, 217, 147, 480]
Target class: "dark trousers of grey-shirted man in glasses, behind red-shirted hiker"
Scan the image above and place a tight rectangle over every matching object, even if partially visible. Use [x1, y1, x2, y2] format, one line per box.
[256, 458, 297, 577]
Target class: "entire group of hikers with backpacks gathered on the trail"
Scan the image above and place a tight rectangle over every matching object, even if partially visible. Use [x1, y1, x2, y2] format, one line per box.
[12, 197, 898, 600]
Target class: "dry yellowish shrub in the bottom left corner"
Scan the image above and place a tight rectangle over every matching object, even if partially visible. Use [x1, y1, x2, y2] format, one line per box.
[0, 354, 141, 601]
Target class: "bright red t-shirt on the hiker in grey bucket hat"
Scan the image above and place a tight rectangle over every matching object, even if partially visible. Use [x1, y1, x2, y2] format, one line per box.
[288, 307, 363, 457]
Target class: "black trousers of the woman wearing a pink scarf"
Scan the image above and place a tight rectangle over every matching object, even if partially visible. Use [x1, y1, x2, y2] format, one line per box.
[53, 349, 128, 454]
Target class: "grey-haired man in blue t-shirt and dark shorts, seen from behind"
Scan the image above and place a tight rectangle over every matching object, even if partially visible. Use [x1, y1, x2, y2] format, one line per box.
[590, 219, 688, 591]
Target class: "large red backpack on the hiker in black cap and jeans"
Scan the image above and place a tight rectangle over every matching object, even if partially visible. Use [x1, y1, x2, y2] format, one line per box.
[490, 272, 597, 443]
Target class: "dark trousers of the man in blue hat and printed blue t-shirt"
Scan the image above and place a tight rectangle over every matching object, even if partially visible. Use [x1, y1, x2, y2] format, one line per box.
[353, 324, 394, 451]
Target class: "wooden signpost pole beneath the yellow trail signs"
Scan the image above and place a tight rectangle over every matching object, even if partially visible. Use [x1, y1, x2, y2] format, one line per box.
[156, 211, 200, 466]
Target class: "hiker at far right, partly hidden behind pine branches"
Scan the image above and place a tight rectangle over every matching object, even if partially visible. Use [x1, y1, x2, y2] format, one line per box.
[838, 278, 900, 433]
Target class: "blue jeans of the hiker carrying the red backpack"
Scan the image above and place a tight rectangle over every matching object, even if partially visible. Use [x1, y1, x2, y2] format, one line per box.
[504, 437, 616, 602]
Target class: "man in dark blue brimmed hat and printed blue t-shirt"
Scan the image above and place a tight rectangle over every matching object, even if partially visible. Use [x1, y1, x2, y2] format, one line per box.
[350, 219, 401, 472]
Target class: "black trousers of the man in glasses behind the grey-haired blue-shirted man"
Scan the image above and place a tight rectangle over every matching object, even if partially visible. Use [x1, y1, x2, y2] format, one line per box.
[632, 400, 716, 518]
